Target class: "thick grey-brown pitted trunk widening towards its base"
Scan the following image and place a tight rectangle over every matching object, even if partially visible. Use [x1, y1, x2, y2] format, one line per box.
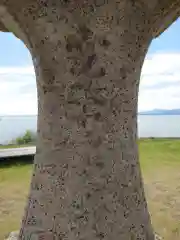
[19, 1, 154, 240]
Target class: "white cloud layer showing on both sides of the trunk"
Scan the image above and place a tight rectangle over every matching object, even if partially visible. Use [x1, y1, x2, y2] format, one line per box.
[0, 52, 180, 115]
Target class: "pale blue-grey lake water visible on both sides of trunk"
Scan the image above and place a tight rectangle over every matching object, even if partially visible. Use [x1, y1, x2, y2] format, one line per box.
[0, 115, 180, 144]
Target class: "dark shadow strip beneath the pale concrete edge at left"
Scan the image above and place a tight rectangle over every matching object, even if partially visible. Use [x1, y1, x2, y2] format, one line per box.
[0, 155, 34, 169]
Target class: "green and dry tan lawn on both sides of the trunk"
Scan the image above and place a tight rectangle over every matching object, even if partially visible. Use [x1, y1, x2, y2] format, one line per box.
[0, 139, 180, 240]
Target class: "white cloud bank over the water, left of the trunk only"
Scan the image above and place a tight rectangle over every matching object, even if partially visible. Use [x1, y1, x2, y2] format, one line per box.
[0, 66, 37, 115]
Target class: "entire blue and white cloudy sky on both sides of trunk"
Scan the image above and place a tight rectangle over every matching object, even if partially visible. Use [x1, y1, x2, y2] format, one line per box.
[0, 19, 180, 115]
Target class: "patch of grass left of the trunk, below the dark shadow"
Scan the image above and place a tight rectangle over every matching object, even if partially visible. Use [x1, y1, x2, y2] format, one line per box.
[0, 160, 32, 240]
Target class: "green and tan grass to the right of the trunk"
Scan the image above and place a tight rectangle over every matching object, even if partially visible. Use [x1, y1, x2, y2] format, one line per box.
[139, 139, 180, 240]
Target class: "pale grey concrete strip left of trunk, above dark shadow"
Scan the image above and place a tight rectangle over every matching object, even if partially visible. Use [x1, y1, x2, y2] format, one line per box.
[0, 147, 36, 158]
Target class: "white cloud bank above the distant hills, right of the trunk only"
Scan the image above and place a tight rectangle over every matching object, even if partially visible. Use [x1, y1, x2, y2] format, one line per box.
[138, 52, 180, 111]
